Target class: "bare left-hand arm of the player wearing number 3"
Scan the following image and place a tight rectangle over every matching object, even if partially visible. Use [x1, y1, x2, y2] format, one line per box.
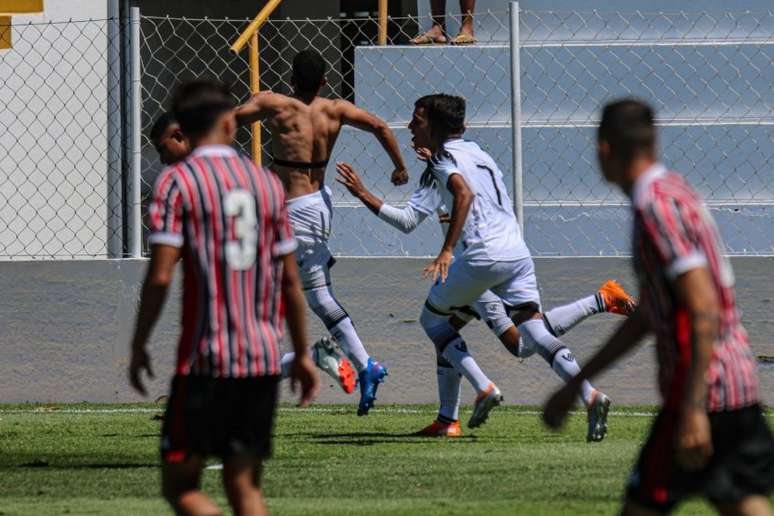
[129, 244, 180, 396]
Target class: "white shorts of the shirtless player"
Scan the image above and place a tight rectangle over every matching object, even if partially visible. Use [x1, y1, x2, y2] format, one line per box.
[288, 186, 336, 290]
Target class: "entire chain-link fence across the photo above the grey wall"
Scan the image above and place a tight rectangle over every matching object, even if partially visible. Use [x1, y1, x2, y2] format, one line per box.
[0, 11, 774, 258]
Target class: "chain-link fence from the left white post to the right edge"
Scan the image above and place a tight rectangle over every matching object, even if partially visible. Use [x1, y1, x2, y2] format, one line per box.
[138, 7, 774, 256]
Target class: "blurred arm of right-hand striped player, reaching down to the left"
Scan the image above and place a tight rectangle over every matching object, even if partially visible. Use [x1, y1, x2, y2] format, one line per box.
[543, 305, 650, 429]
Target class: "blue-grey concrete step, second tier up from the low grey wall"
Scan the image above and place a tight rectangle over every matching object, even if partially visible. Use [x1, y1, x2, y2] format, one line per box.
[327, 125, 774, 205]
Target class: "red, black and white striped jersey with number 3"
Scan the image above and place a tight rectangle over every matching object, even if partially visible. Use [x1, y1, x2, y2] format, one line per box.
[149, 146, 296, 378]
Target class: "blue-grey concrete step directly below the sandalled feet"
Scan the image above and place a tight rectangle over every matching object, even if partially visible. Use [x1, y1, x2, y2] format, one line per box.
[355, 43, 774, 125]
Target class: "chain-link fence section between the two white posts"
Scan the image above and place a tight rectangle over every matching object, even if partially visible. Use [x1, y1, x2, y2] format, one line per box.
[142, 13, 511, 256]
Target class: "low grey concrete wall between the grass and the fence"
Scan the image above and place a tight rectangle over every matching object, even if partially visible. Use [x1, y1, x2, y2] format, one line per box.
[0, 258, 774, 404]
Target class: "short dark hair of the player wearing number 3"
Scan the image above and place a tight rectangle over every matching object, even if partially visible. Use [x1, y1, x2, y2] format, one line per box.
[172, 79, 236, 138]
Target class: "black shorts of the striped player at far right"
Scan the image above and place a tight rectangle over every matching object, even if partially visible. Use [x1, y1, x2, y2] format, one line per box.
[626, 405, 774, 512]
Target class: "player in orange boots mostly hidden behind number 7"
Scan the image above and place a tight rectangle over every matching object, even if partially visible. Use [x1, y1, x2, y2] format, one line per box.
[337, 158, 635, 441]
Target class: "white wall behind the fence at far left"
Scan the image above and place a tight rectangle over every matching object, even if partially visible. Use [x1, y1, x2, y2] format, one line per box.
[0, 0, 113, 259]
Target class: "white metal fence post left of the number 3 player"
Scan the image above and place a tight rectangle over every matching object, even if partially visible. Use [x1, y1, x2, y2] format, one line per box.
[127, 7, 142, 258]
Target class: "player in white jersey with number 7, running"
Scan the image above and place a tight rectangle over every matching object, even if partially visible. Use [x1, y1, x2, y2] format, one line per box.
[398, 94, 610, 433]
